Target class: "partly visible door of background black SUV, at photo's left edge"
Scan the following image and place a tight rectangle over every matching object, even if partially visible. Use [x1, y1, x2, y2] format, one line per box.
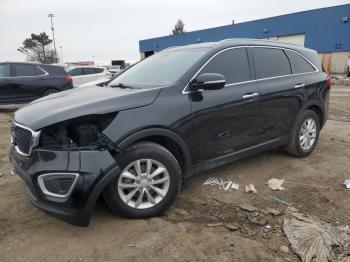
[0, 63, 14, 103]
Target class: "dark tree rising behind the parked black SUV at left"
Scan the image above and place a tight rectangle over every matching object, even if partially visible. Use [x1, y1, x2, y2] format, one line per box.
[17, 32, 59, 64]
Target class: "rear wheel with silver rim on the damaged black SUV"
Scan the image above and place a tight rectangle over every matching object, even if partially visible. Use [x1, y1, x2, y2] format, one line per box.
[285, 110, 320, 157]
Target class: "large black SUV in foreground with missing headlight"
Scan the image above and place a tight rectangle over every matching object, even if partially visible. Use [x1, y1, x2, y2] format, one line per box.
[10, 39, 330, 225]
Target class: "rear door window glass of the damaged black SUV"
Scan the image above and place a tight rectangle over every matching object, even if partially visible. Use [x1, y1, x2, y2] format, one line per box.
[252, 47, 292, 79]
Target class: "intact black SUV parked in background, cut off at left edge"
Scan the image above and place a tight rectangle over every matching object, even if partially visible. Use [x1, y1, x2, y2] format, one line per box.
[0, 62, 73, 104]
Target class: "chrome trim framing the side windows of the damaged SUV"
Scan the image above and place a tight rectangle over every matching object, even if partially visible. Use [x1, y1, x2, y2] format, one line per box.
[182, 45, 320, 95]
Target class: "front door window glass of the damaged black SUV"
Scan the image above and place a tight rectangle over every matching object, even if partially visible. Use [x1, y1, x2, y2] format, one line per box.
[200, 48, 250, 84]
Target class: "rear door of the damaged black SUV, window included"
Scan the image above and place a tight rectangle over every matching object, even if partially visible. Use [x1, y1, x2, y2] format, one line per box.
[250, 47, 304, 142]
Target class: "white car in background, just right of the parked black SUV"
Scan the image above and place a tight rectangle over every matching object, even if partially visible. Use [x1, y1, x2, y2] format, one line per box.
[66, 66, 112, 87]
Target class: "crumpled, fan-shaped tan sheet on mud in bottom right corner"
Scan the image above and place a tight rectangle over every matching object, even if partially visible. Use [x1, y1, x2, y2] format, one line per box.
[282, 207, 350, 262]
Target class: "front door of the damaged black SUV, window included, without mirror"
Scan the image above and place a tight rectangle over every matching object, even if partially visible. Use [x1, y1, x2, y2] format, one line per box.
[189, 48, 260, 163]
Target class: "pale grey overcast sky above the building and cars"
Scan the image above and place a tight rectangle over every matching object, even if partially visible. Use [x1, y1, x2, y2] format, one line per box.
[0, 0, 349, 62]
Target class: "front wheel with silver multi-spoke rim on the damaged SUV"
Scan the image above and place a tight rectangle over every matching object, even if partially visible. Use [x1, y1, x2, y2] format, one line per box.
[103, 142, 182, 218]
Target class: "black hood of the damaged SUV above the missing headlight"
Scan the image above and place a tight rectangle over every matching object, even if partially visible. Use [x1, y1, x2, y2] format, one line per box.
[14, 86, 161, 130]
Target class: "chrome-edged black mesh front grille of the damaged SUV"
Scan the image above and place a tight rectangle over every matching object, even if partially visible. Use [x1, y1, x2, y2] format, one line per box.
[11, 122, 40, 156]
